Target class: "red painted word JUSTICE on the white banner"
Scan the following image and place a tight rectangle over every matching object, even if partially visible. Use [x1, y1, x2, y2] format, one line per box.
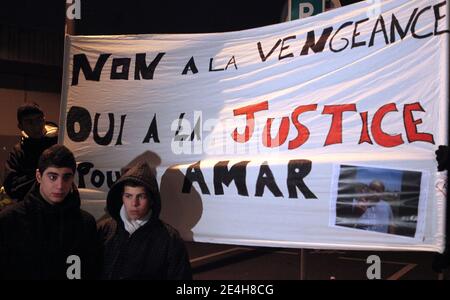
[232, 101, 434, 150]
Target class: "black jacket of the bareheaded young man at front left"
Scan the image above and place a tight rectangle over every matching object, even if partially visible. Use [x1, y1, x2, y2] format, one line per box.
[0, 184, 100, 279]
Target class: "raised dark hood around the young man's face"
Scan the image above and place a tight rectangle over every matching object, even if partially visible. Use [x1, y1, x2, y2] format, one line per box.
[106, 163, 161, 221]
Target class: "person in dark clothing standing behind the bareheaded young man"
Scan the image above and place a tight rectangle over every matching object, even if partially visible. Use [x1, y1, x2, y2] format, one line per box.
[3, 103, 58, 201]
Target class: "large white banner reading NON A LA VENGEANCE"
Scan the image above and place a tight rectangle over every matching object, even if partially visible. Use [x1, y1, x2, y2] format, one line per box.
[60, 0, 449, 251]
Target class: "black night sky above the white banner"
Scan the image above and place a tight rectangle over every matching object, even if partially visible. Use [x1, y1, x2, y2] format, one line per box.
[0, 0, 360, 35]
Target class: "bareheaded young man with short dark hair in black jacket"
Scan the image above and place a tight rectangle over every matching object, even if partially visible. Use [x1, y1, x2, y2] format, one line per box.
[0, 145, 100, 279]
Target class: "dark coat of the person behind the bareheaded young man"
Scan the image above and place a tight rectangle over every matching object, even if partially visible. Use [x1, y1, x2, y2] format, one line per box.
[3, 123, 58, 201]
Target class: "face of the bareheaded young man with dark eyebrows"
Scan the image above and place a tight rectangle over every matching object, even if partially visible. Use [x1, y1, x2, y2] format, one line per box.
[36, 167, 74, 204]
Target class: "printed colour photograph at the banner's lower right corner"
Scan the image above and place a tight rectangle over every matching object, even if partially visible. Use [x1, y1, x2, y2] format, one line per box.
[332, 165, 424, 238]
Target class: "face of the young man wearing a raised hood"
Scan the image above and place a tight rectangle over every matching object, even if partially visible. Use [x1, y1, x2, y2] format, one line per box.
[122, 186, 150, 220]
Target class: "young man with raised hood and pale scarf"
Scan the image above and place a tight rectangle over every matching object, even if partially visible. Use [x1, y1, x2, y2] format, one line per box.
[98, 163, 192, 280]
